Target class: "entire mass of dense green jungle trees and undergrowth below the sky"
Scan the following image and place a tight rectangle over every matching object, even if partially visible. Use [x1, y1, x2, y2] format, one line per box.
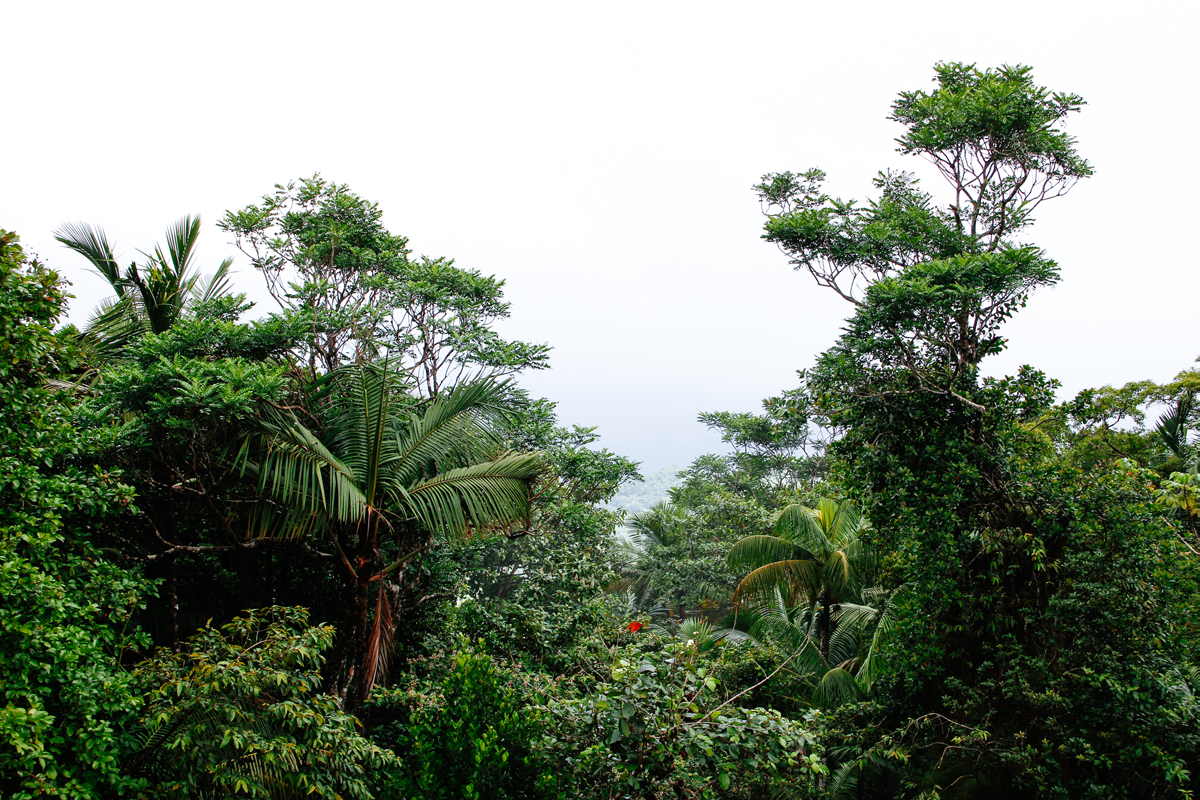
[0, 64, 1200, 800]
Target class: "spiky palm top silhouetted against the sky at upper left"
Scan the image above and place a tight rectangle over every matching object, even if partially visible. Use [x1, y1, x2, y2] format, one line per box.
[54, 216, 233, 359]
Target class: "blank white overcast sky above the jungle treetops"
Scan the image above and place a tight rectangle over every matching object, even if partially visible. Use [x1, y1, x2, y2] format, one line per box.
[0, 0, 1200, 470]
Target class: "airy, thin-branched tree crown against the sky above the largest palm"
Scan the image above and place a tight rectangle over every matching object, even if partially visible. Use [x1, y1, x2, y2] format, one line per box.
[220, 175, 550, 397]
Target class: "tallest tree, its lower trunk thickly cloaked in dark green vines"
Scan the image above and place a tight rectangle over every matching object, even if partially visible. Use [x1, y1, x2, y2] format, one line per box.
[757, 64, 1200, 798]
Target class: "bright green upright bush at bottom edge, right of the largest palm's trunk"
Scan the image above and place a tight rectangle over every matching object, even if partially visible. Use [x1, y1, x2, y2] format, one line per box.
[372, 643, 556, 800]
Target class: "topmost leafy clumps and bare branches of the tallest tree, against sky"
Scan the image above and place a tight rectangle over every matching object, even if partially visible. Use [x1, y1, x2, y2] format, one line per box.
[754, 64, 1092, 303]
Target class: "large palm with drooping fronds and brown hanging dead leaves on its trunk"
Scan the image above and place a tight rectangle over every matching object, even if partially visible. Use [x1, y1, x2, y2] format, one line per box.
[239, 365, 542, 709]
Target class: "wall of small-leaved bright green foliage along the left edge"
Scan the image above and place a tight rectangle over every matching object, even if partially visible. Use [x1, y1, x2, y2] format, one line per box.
[0, 230, 148, 800]
